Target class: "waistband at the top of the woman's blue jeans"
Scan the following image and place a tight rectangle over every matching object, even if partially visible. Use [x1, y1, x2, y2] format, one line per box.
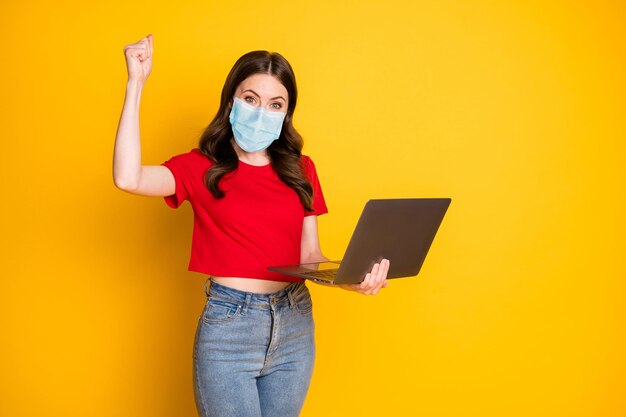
[204, 277, 308, 308]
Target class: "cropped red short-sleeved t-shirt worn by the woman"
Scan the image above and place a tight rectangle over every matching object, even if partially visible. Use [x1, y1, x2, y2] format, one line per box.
[161, 148, 328, 282]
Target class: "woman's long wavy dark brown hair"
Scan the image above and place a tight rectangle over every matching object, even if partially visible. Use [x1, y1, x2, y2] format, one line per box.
[199, 51, 313, 211]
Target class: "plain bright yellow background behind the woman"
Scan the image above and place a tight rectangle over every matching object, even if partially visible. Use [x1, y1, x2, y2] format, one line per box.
[0, 0, 626, 417]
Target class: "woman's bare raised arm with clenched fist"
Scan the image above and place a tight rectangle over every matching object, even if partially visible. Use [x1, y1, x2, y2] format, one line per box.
[113, 35, 176, 196]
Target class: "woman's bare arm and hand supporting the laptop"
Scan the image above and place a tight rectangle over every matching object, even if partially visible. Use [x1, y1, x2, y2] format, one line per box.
[300, 216, 389, 295]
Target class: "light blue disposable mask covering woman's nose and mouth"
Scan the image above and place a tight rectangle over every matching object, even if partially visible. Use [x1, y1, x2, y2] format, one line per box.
[229, 97, 287, 152]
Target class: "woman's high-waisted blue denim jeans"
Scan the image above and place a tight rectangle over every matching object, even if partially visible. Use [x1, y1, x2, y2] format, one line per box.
[193, 280, 315, 417]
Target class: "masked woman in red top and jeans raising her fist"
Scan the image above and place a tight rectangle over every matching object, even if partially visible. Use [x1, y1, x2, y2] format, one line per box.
[113, 35, 389, 417]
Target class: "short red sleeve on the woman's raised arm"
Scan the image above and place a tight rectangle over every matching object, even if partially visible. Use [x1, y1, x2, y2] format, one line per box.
[161, 149, 203, 208]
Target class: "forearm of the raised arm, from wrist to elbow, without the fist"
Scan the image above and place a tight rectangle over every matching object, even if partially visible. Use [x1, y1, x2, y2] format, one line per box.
[113, 80, 143, 189]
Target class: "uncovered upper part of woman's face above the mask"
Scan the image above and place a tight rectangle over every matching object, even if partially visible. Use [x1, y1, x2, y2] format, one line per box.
[235, 74, 289, 112]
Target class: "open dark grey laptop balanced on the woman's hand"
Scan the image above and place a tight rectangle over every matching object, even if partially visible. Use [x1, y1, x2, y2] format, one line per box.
[267, 198, 451, 284]
